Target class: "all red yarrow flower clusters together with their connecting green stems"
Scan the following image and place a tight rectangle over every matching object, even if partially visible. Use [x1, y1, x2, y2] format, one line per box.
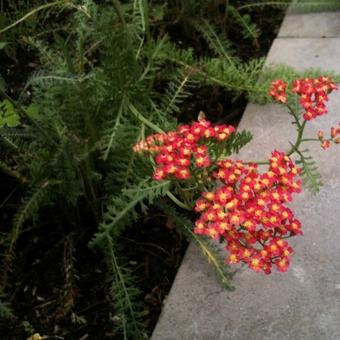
[134, 76, 340, 274]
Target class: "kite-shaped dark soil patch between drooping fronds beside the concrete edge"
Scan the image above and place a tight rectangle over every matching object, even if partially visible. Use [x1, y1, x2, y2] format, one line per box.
[123, 209, 188, 332]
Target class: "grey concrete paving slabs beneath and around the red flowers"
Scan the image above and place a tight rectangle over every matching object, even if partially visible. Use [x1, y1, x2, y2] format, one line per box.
[152, 12, 340, 340]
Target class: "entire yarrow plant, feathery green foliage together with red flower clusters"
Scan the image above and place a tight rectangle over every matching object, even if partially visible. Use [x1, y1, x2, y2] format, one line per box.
[0, 0, 339, 340]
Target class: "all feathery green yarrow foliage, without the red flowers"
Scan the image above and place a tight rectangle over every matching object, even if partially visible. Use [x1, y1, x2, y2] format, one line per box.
[0, 0, 340, 339]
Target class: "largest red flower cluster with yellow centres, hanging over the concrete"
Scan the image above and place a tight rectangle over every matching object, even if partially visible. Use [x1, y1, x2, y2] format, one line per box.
[195, 151, 302, 274]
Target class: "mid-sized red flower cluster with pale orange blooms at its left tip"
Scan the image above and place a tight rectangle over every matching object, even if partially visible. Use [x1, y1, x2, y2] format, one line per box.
[134, 119, 235, 180]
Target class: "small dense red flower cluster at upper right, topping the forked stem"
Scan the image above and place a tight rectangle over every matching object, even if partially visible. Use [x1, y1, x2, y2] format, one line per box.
[292, 76, 337, 120]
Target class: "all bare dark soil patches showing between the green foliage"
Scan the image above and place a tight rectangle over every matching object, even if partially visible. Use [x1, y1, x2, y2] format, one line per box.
[0, 1, 283, 340]
